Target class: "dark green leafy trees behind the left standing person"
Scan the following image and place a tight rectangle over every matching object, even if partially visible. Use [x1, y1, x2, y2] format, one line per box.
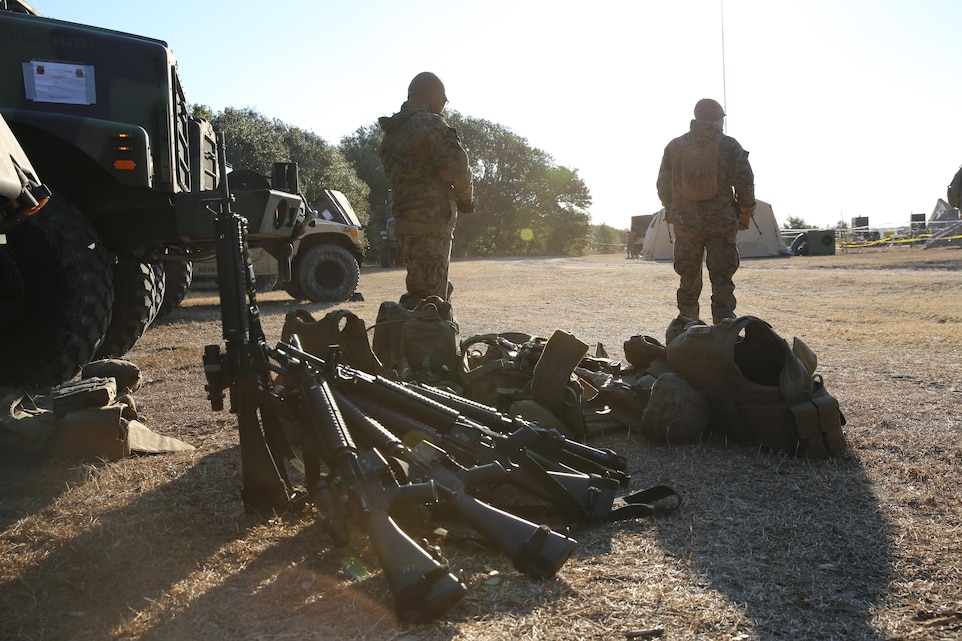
[193, 105, 625, 257]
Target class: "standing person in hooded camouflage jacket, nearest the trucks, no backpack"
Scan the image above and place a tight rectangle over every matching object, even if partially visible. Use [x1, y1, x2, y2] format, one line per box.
[378, 71, 474, 307]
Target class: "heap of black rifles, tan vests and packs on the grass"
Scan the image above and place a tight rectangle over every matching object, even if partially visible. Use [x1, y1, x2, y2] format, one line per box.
[238, 297, 845, 622]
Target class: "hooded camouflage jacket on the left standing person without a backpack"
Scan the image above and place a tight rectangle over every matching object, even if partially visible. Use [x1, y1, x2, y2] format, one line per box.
[378, 100, 474, 238]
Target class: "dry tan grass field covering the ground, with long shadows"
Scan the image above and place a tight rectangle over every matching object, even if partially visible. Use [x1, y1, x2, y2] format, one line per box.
[0, 249, 962, 641]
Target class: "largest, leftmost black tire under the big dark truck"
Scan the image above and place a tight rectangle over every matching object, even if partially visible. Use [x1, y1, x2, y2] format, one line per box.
[0, 195, 113, 391]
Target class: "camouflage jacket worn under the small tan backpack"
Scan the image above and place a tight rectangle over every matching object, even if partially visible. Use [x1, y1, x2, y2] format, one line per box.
[657, 120, 755, 222]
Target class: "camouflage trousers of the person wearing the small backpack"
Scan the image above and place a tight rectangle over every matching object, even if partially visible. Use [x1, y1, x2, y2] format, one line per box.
[674, 214, 738, 324]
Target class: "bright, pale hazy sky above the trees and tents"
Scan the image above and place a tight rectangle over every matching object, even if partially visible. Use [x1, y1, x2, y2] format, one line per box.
[30, 0, 962, 228]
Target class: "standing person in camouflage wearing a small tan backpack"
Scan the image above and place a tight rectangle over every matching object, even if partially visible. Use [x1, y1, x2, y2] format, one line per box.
[657, 98, 755, 324]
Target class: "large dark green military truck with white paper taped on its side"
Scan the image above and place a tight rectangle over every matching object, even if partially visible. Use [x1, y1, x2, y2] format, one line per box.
[0, 0, 308, 387]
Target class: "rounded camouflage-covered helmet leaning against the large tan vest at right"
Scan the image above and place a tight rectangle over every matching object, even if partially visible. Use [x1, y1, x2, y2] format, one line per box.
[641, 372, 711, 445]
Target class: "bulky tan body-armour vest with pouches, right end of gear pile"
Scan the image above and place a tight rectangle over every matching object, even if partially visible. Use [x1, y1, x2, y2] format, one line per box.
[666, 316, 846, 458]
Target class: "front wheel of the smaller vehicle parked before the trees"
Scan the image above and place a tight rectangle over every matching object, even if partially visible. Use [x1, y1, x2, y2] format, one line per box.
[292, 245, 361, 303]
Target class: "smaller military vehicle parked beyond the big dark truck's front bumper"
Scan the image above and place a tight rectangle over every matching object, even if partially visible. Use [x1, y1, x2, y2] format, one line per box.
[193, 189, 364, 303]
